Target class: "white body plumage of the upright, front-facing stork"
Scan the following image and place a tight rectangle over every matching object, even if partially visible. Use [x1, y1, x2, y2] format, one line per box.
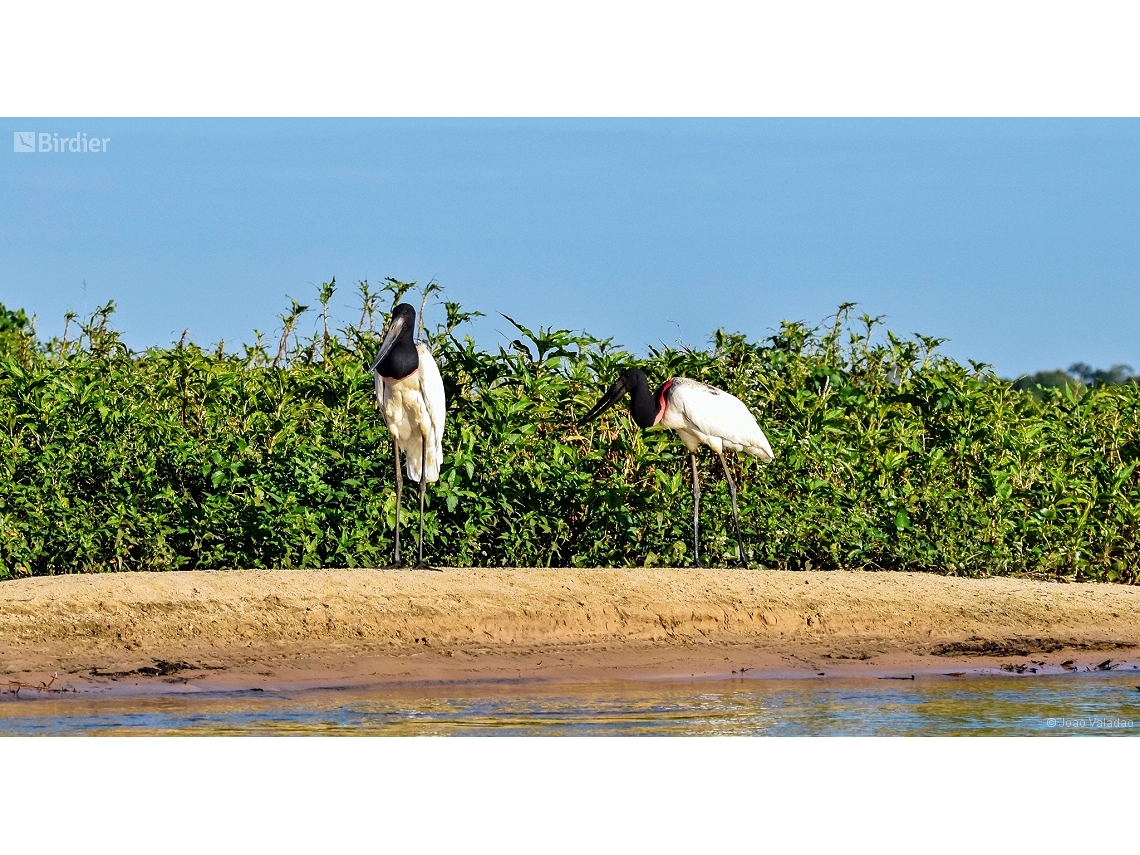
[375, 342, 446, 482]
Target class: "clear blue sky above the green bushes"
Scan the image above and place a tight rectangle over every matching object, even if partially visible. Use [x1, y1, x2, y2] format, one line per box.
[0, 119, 1140, 376]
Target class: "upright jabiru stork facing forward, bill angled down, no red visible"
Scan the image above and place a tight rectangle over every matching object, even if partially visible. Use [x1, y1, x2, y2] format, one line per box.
[371, 303, 446, 568]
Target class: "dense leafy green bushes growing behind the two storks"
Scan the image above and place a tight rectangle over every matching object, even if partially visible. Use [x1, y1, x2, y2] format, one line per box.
[0, 280, 1140, 583]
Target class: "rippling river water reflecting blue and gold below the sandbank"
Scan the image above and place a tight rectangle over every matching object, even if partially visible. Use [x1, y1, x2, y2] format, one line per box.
[0, 673, 1140, 736]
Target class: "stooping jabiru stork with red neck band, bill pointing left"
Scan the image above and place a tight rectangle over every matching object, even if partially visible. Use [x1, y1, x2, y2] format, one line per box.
[578, 368, 773, 567]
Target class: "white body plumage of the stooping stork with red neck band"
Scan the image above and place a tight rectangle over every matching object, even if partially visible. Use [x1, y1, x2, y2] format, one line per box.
[661, 377, 774, 463]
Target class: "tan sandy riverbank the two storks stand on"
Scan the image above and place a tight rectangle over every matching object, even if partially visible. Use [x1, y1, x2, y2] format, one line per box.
[0, 569, 1140, 693]
